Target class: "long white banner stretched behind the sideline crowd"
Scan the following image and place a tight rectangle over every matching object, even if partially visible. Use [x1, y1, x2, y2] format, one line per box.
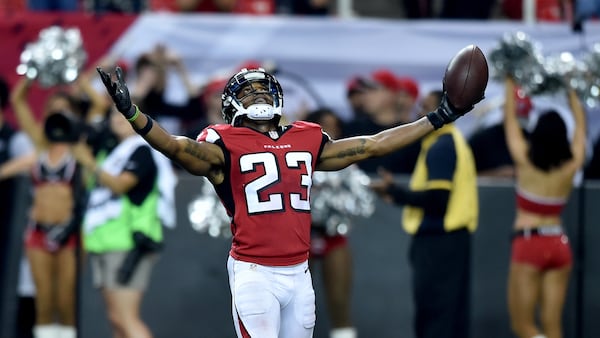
[112, 13, 600, 135]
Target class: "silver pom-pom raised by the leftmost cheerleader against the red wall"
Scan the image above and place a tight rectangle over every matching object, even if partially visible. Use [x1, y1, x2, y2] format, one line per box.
[17, 26, 87, 88]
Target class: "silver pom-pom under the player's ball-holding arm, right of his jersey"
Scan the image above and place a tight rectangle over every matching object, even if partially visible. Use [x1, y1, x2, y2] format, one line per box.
[310, 166, 375, 235]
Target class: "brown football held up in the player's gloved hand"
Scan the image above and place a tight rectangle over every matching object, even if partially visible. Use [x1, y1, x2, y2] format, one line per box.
[443, 45, 488, 109]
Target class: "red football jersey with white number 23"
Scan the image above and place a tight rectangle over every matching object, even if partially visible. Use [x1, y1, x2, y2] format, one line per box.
[197, 121, 329, 266]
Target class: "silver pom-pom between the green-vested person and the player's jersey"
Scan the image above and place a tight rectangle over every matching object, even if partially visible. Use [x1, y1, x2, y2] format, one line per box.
[188, 178, 231, 238]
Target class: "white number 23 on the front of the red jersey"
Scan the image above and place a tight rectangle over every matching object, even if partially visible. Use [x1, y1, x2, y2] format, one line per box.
[240, 152, 312, 214]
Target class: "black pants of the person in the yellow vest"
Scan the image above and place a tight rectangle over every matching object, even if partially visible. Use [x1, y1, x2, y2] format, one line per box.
[409, 230, 471, 338]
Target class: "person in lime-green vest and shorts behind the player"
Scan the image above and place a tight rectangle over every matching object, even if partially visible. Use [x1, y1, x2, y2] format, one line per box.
[73, 106, 176, 338]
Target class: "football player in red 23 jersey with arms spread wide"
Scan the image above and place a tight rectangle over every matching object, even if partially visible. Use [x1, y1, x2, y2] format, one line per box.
[98, 68, 470, 338]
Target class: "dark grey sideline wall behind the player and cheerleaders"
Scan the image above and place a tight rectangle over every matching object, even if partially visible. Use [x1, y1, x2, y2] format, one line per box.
[76, 175, 600, 338]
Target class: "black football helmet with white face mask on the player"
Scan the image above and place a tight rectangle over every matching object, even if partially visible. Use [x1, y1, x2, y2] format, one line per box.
[221, 68, 283, 126]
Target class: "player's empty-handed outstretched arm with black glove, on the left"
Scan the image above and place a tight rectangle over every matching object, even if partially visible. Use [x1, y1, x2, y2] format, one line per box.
[98, 67, 225, 184]
